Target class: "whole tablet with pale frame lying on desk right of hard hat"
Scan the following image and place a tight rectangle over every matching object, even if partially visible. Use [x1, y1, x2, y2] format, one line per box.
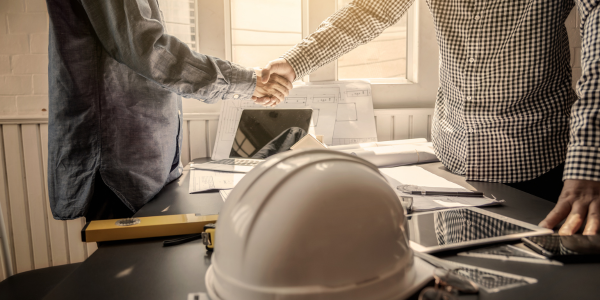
[407, 207, 552, 253]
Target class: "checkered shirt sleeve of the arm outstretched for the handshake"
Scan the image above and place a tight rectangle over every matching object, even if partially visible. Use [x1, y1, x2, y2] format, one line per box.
[282, 0, 414, 79]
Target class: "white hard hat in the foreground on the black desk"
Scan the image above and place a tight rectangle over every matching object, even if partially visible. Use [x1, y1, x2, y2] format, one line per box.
[206, 150, 433, 300]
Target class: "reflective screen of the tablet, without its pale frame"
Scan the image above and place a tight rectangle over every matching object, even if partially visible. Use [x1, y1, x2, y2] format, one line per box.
[408, 208, 533, 247]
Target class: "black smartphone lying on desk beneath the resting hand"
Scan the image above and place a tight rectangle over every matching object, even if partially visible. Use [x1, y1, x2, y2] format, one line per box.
[521, 234, 600, 263]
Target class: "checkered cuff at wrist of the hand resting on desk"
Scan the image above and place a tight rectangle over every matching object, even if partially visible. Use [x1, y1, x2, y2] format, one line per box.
[563, 146, 600, 181]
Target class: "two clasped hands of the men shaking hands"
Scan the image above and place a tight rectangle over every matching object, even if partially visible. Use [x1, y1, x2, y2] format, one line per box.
[252, 58, 296, 107]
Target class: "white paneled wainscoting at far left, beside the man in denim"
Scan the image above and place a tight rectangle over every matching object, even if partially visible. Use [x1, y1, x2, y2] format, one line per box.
[0, 118, 97, 279]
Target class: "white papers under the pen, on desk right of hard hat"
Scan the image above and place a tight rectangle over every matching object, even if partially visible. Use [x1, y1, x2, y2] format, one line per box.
[379, 166, 504, 211]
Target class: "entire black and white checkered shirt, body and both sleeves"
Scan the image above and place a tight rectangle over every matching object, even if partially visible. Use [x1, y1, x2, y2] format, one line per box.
[283, 0, 600, 183]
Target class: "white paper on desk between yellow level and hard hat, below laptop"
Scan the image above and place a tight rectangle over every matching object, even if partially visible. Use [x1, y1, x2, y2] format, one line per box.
[189, 169, 246, 194]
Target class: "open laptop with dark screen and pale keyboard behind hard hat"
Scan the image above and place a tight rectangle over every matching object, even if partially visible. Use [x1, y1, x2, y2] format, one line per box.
[192, 108, 312, 173]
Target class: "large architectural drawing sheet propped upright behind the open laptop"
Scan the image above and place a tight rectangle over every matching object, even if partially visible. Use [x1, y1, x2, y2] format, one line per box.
[211, 81, 377, 160]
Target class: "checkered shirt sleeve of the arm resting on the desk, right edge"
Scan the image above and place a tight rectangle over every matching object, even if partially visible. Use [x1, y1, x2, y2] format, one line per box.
[563, 0, 600, 181]
